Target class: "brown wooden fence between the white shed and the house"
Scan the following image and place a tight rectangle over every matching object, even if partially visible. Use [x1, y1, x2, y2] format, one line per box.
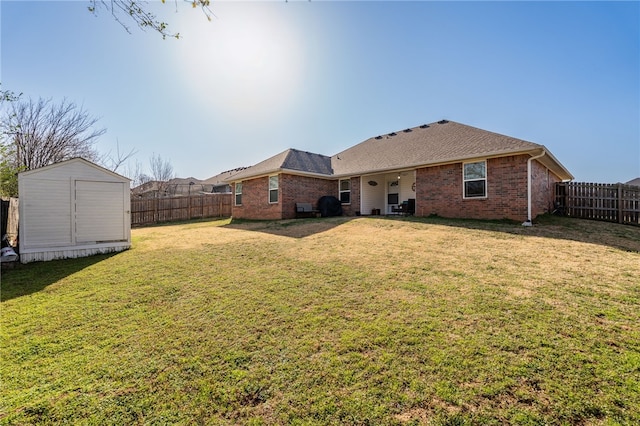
[131, 194, 232, 226]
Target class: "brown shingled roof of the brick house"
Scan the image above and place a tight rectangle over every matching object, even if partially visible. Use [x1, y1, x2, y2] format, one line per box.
[229, 120, 573, 181]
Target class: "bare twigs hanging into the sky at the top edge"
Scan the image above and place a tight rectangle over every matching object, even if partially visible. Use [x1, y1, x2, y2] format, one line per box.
[89, 0, 213, 39]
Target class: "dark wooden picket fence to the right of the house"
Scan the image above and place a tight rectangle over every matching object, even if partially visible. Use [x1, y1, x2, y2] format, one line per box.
[555, 182, 640, 225]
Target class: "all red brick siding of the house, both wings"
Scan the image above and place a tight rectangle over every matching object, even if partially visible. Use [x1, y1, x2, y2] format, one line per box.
[233, 155, 560, 221]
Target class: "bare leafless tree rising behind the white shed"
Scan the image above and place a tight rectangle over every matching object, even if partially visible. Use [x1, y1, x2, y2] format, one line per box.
[2, 99, 106, 170]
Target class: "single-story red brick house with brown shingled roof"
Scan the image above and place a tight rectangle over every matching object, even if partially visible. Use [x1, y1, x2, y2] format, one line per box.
[228, 120, 573, 224]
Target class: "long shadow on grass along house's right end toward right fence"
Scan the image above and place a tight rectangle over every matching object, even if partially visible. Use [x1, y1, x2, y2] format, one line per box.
[396, 215, 640, 253]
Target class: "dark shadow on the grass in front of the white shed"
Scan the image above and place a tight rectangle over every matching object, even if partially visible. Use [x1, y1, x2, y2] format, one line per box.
[0, 253, 118, 302]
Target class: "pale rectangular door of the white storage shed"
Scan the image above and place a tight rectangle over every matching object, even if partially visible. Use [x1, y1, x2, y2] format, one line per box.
[75, 180, 127, 243]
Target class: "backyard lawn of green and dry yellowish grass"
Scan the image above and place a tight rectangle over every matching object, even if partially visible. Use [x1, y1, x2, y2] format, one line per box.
[0, 218, 640, 425]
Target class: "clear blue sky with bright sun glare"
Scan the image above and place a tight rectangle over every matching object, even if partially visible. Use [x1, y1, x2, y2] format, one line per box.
[0, 0, 640, 183]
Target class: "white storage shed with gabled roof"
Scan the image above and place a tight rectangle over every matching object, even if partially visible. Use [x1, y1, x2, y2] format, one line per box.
[18, 158, 131, 263]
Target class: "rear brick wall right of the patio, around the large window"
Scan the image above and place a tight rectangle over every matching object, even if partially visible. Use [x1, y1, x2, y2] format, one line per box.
[416, 155, 542, 221]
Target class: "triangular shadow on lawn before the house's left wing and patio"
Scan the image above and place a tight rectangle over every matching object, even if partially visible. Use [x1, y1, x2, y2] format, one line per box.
[223, 216, 355, 238]
